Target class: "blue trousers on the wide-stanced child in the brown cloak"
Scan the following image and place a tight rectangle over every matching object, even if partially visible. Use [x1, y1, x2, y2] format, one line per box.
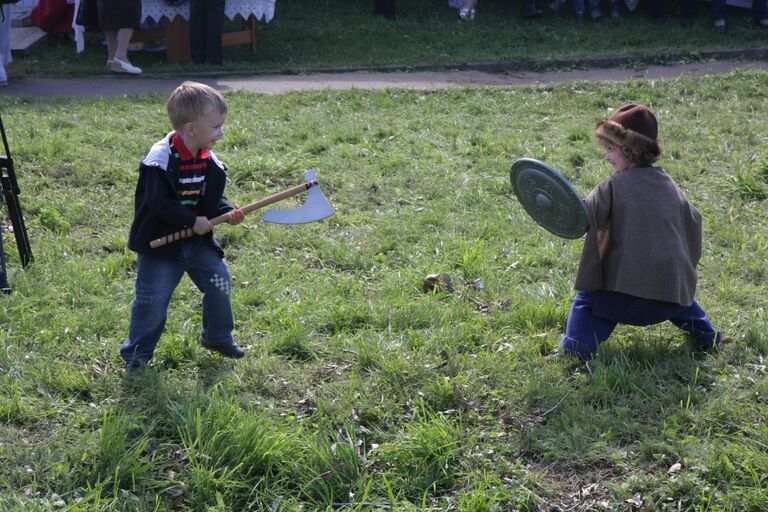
[560, 291, 721, 361]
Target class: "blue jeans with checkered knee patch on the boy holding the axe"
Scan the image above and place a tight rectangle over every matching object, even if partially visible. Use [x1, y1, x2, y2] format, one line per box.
[120, 236, 235, 366]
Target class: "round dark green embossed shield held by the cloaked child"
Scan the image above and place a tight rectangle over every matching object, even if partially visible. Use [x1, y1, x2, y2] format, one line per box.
[509, 158, 587, 239]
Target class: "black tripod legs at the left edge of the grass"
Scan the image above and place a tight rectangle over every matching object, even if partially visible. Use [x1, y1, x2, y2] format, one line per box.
[0, 116, 32, 293]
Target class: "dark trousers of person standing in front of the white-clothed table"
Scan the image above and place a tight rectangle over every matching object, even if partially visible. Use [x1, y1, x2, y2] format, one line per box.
[189, 0, 224, 64]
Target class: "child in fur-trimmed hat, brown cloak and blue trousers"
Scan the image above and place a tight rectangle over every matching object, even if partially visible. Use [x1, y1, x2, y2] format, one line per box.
[560, 103, 721, 361]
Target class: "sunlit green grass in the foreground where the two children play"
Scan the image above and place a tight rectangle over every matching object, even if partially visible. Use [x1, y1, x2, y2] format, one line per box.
[0, 72, 768, 511]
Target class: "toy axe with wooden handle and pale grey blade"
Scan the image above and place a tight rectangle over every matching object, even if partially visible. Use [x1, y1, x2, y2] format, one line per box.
[149, 171, 336, 249]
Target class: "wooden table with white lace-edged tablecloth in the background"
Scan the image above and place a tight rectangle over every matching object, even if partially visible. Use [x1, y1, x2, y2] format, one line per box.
[131, 0, 276, 63]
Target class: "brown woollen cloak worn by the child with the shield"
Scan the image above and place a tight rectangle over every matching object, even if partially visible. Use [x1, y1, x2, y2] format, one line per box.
[575, 167, 702, 306]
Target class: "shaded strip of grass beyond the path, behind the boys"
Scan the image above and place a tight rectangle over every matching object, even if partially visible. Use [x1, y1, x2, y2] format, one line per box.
[10, 0, 766, 78]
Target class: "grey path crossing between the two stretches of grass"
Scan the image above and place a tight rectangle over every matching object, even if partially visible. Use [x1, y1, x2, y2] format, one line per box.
[0, 61, 768, 97]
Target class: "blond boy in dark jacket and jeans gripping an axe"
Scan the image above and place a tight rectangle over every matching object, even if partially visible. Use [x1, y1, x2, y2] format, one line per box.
[120, 82, 245, 369]
